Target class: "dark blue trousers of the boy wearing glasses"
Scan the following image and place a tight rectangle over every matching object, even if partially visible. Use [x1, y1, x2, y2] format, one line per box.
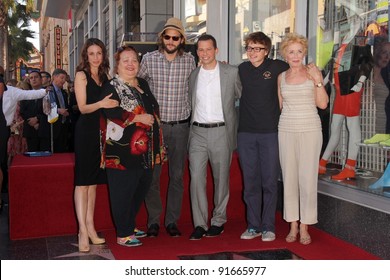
[238, 132, 280, 232]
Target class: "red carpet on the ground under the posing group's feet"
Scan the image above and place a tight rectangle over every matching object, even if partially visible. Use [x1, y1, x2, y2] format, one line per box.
[104, 213, 379, 260]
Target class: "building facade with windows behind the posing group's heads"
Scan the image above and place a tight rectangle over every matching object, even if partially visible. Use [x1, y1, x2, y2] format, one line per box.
[35, 0, 390, 199]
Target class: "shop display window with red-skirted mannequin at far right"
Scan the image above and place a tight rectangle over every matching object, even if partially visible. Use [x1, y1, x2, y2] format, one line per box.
[316, 0, 390, 197]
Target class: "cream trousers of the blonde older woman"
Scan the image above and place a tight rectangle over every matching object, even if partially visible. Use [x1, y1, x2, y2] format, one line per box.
[279, 131, 322, 225]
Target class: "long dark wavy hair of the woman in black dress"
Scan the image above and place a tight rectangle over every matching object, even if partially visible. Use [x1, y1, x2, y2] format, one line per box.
[76, 38, 110, 81]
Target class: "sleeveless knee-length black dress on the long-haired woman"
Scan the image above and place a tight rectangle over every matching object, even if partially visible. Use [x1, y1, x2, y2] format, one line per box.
[74, 71, 108, 186]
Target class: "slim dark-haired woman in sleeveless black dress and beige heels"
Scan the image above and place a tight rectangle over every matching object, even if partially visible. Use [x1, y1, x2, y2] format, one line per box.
[74, 38, 118, 252]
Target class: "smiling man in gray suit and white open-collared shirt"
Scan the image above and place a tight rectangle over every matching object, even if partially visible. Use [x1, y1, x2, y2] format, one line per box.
[189, 34, 241, 240]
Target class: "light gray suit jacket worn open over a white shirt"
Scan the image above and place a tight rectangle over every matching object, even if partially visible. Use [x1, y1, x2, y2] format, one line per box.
[189, 62, 242, 152]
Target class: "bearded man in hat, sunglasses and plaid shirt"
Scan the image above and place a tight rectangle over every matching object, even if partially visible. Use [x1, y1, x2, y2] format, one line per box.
[138, 18, 196, 237]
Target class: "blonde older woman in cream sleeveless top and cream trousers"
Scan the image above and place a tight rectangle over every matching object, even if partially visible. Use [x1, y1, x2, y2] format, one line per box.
[278, 33, 329, 245]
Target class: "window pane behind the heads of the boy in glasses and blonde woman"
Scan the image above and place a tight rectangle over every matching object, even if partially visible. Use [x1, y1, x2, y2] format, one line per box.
[229, 0, 295, 64]
